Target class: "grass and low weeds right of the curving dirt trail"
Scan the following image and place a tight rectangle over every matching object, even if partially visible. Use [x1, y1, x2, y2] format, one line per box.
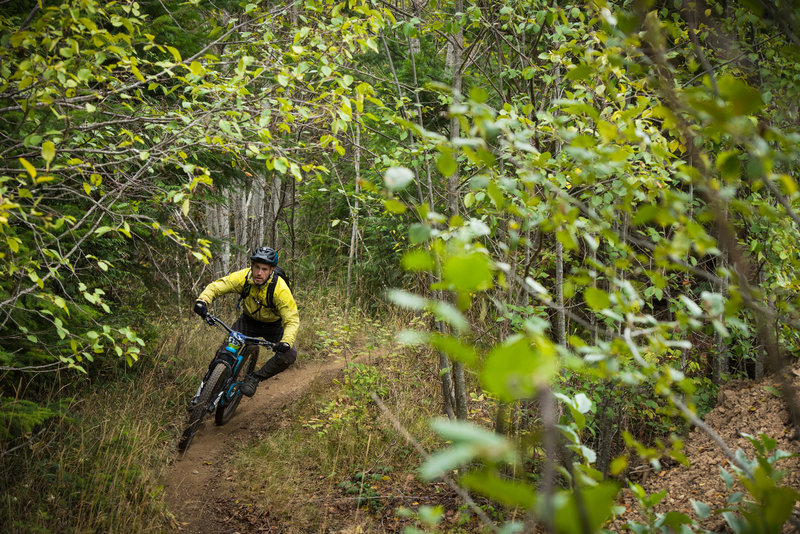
[225, 293, 440, 533]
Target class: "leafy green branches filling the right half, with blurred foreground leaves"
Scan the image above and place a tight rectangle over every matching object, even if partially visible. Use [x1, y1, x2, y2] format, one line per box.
[382, 2, 800, 532]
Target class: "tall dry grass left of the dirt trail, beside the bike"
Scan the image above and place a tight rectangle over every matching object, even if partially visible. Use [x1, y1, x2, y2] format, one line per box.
[0, 314, 218, 533]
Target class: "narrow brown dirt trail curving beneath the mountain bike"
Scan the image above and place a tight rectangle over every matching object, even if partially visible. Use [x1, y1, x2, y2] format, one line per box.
[161, 355, 358, 534]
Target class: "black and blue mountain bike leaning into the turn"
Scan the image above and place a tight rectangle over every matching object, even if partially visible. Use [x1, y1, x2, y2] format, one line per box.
[178, 313, 276, 452]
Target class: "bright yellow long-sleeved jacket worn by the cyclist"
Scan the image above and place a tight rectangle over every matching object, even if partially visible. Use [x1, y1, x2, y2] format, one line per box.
[197, 268, 300, 346]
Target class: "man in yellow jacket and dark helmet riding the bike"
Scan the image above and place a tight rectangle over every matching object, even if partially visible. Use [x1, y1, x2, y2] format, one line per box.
[194, 247, 300, 397]
